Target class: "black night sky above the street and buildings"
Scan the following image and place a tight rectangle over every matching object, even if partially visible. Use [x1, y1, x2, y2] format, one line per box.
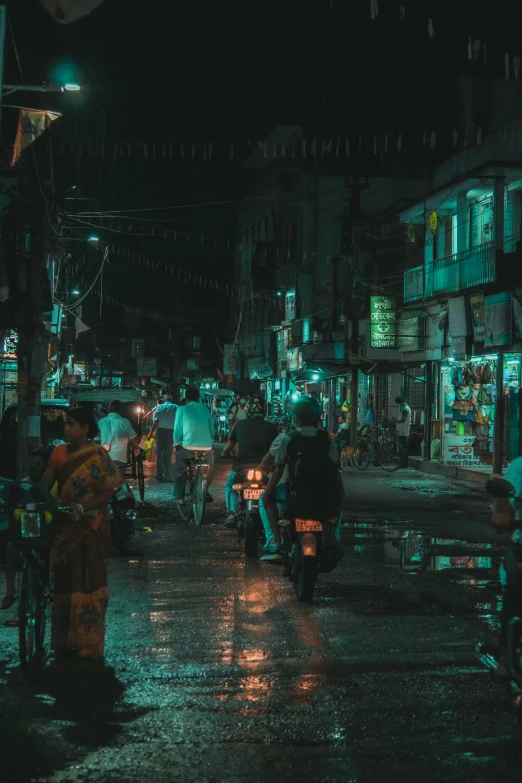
[2, 0, 522, 356]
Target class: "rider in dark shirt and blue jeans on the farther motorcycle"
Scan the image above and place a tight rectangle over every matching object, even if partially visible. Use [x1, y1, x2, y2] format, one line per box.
[222, 397, 279, 527]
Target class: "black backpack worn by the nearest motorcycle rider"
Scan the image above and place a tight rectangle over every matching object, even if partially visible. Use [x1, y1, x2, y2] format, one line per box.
[287, 430, 341, 521]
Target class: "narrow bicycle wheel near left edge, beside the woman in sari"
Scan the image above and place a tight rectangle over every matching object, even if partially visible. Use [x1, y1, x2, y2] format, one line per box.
[19, 558, 46, 672]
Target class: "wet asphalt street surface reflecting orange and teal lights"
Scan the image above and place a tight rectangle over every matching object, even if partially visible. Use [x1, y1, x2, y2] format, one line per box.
[0, 456, 522, 783]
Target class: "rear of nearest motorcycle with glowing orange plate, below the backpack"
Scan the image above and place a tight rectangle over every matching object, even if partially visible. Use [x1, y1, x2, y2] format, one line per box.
[279, 517, 344, 603]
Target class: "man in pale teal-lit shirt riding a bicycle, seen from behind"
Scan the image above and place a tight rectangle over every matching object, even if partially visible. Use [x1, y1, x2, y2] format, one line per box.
[174, 389, 214, 502]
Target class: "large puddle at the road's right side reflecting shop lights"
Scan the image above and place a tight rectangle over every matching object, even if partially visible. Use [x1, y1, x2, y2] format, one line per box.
[343, 522, 503, 586]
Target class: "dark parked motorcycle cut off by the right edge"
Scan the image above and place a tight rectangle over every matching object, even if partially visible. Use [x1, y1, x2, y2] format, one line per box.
[477, 477, 522, 719]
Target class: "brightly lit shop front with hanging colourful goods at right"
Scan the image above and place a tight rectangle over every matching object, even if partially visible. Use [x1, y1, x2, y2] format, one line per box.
[435, 353, 522, 472]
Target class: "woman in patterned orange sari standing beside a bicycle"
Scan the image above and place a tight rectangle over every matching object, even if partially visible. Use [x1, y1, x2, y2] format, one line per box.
[43, 408, 122, 658]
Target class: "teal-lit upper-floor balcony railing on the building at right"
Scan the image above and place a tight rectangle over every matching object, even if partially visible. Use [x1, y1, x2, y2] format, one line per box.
[404, 242, 495, 302]
